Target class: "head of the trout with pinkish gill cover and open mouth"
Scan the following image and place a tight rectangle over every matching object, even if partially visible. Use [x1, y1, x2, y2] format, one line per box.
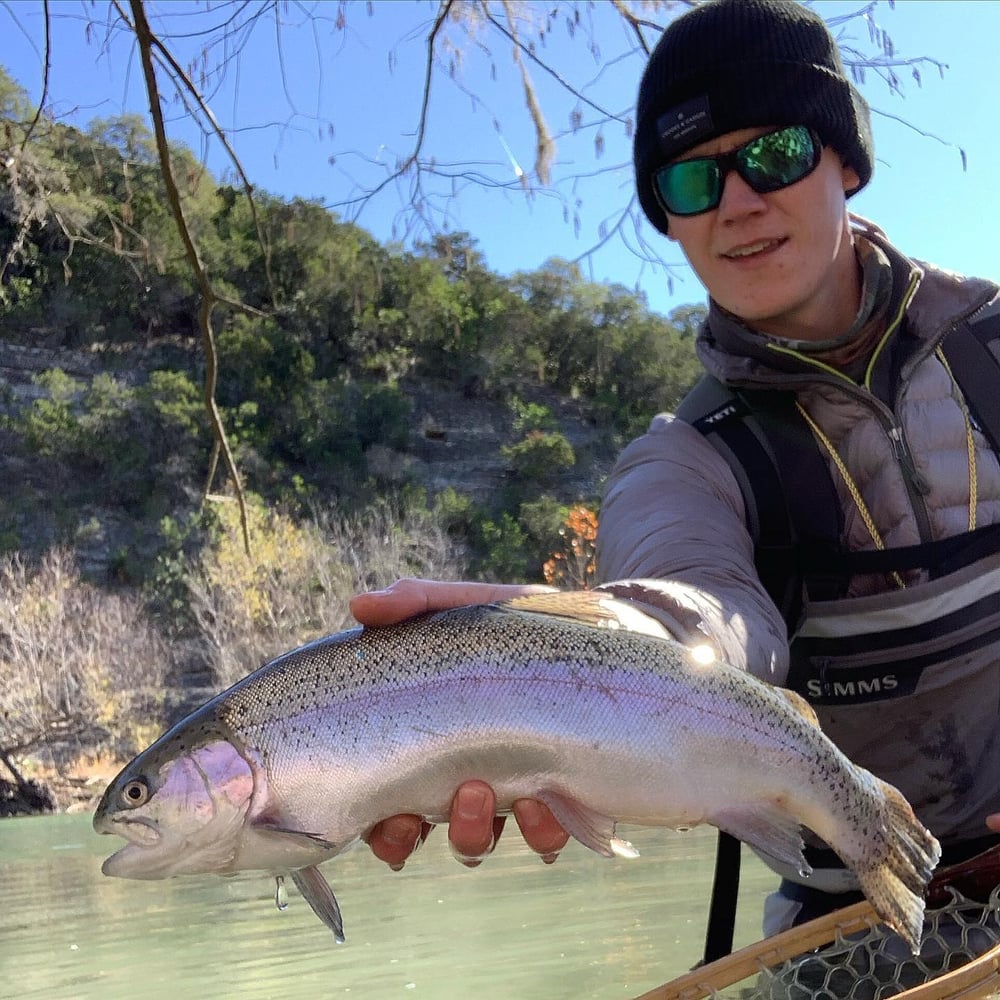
[94, 733, 254, 879]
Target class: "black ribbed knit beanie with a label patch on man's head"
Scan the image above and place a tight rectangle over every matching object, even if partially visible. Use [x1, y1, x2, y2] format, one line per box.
[633, 0, 874, 233]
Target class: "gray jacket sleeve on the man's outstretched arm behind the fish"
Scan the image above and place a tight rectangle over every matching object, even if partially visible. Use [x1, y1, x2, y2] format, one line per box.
[597, 416, 788, 684]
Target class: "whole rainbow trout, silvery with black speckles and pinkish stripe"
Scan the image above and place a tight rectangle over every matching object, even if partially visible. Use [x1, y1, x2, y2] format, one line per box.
[94, 592, 940, 951]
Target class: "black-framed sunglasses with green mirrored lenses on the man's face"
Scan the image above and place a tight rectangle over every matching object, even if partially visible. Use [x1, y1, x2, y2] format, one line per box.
[653, 125, 823, 215]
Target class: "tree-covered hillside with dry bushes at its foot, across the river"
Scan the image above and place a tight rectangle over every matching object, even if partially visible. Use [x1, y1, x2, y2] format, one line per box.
[0, 70, 702, 808]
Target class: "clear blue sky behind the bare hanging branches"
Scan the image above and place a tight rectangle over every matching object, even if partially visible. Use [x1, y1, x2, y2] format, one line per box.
[0, 0, 1000, 312]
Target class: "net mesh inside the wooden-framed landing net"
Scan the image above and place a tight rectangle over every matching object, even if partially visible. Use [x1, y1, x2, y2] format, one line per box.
[712, 887, 1000, 1000]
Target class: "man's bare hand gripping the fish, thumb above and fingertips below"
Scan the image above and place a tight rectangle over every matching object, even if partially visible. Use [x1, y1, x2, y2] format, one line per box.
[351, 579, 569, 870]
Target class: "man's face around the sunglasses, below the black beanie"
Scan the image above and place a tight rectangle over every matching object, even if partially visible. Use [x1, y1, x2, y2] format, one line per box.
[668, 128, 861, 340]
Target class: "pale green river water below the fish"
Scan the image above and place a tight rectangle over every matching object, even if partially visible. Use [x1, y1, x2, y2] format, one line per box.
[0, 815, 775, 1000]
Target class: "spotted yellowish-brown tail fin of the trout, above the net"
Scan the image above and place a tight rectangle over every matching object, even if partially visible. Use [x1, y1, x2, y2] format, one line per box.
[857, 782, 941, 955]
